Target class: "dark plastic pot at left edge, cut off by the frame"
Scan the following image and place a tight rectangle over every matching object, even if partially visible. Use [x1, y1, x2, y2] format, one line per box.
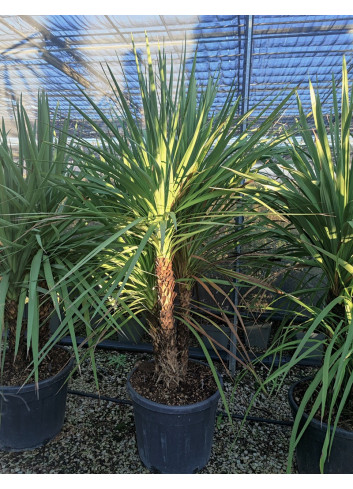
[0, 350, 74, 451]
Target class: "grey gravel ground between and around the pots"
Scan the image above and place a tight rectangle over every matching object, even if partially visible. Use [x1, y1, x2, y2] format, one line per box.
[0, 350, 312, 474]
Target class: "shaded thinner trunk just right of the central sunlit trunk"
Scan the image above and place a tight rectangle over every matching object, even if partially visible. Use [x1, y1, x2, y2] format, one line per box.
[177, 284, 191, 378]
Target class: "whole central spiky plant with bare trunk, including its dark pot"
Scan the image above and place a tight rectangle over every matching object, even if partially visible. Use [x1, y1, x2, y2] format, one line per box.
[66, 39, 287, 473]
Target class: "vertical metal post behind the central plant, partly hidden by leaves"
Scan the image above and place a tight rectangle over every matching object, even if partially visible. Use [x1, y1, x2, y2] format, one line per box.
[229, 15, 254, 375]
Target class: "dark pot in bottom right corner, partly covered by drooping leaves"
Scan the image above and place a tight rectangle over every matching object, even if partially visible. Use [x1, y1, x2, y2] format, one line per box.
[288, 379, 353, 474]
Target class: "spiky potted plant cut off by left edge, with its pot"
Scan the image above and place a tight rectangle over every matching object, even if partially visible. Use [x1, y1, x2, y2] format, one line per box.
[0, 93, 103, 450]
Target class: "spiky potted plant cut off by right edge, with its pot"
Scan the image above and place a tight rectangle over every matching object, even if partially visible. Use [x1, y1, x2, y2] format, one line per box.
[241, 60, 353, 473]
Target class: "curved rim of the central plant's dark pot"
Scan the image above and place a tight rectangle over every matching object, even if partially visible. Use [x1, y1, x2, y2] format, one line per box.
[127, 360, 223, 414]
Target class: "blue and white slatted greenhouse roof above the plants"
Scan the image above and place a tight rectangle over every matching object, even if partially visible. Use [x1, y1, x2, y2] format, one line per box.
[0, 15, 353, 133]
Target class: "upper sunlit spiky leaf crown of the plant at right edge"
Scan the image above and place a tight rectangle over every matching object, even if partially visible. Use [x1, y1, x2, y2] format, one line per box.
[243, 57, 353, 303]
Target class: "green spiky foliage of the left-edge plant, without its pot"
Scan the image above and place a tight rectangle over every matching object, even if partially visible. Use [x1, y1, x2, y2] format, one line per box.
[0, 93, 103, 381]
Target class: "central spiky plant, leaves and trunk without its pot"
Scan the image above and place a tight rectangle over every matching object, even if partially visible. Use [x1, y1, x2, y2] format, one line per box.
[64, 37, 287, 387]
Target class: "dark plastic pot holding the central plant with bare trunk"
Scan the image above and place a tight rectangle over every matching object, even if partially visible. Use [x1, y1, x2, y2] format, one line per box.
[127, 362, 221, 474]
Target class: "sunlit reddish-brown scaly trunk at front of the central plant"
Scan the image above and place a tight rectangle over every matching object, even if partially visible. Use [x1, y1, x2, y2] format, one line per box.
[151, 257, 180, 388]
